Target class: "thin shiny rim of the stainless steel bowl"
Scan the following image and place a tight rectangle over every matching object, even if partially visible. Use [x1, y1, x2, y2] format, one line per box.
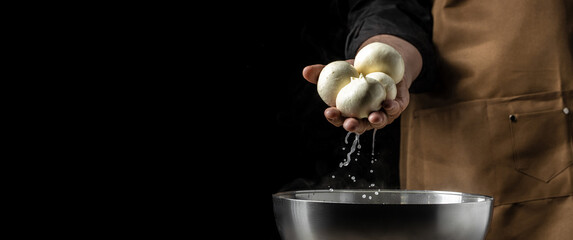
[272, 189, 494, 205]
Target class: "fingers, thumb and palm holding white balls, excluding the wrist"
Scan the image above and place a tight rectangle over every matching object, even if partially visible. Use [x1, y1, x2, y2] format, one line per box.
[302, 62, 410, 133]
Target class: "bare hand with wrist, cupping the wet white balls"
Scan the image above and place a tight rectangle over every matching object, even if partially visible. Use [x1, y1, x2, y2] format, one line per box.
[302, 35, 422, 133]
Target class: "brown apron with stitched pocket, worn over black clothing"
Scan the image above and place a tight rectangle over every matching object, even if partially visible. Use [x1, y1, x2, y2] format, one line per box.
[400, 0, 573, 240]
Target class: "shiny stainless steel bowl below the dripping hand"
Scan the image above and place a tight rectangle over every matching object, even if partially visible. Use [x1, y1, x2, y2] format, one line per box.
[273, 190, 493, 240]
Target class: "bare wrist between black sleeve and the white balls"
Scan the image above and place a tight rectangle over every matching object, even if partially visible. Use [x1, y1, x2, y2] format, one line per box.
[360, 34, 423, 88]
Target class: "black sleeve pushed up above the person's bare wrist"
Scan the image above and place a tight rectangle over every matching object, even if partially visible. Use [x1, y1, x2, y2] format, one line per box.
[346, 0, 436, 93]
